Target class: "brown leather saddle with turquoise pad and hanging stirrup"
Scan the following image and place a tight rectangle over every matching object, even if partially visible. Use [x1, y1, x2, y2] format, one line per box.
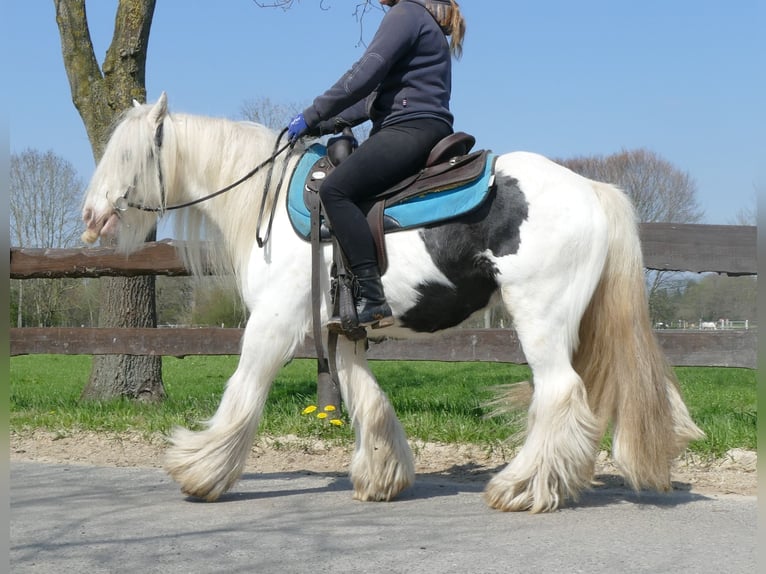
[294, 128, 495, 418]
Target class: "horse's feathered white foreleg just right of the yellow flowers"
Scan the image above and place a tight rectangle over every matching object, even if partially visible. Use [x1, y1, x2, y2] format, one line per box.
[338, 337, 415, 501]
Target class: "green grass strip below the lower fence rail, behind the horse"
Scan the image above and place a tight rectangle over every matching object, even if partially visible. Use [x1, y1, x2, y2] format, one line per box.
[10, 355, 757, 456]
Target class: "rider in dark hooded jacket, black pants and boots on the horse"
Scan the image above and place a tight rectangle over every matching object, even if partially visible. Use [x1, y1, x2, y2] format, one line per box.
[288, 0, 465, 328]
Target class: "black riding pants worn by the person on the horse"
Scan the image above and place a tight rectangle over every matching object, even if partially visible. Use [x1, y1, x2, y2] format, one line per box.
[319, 118, 452, 272]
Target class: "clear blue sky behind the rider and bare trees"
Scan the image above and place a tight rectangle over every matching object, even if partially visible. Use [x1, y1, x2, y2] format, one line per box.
[5, 0, 766, 224]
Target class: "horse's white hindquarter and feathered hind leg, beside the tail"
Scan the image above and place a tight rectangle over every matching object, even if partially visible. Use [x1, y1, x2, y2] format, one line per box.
[485, 153, 620, 512]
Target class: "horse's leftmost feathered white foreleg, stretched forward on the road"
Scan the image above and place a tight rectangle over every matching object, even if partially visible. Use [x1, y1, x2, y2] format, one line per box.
[165, 286, 308, 501]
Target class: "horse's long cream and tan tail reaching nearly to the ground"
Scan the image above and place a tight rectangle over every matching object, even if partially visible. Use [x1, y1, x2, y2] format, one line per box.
[573, 182, 704, 490]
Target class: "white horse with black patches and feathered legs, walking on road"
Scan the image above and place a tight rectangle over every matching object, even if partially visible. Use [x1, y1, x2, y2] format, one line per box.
[82, 92, 702, 513]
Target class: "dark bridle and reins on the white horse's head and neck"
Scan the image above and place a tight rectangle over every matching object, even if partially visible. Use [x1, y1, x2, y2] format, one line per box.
[112, 122, 294, 247]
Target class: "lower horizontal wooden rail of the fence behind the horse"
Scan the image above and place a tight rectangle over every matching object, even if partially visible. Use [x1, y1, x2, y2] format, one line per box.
[11, 327, 758, 369]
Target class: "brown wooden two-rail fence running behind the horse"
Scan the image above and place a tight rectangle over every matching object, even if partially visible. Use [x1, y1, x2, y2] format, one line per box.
[10, 223, 757, 368]
